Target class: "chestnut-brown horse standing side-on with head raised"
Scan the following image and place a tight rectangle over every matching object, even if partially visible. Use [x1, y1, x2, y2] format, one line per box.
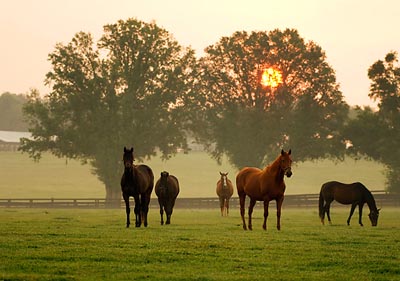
[236, 149, 292, 230]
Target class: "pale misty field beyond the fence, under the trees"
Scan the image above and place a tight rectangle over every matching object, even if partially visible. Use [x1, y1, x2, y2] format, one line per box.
[0, 150, 385, 198]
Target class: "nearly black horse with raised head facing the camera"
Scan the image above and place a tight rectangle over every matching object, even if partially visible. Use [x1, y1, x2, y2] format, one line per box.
[121, 147, 154, 227]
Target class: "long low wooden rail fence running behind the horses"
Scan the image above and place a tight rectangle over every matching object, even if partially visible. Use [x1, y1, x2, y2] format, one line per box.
[0, 191, 400, 209]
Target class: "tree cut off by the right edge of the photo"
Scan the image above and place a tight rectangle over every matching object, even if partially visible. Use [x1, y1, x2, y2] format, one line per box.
[345, 52, 400, 192]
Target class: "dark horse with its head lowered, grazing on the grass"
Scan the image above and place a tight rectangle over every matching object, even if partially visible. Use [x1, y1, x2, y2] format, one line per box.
[319, 181, 379, 226]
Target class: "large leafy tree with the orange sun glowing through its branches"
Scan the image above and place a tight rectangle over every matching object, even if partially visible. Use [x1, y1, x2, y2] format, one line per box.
[197, 29, 348, 168]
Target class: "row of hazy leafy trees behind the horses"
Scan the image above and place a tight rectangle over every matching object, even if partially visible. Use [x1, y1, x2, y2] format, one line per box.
[2, 19, 400, 199]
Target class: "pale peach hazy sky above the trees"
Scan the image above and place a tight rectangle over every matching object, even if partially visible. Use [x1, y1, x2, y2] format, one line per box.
[0, 0, 400, 105]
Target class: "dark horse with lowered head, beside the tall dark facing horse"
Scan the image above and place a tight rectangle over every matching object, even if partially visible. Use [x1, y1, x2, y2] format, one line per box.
[156, 171, 179, 225]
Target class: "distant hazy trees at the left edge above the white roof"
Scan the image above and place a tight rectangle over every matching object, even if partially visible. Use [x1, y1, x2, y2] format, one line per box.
[0, 92, 28, 132]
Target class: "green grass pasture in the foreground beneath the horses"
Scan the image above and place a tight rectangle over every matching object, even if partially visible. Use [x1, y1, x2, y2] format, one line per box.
[0, 206, 400, 280]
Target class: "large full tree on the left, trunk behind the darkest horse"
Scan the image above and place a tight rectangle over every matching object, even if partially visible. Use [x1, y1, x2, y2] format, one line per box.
[22, 19, 196, 200]
